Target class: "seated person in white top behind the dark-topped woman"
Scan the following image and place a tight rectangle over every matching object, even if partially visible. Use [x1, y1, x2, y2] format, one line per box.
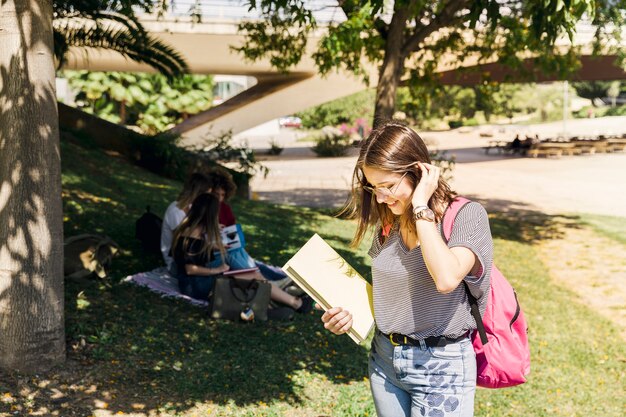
[161, 172, 213, 274]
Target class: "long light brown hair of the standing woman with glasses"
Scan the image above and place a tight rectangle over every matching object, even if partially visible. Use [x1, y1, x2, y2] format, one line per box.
[340, 122, 456, 246]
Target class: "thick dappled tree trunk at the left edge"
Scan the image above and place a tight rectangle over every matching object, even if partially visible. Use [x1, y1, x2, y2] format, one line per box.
[0, 0, 65, 372]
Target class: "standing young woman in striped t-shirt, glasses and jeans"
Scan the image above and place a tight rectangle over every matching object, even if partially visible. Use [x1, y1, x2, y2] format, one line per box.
[322, 122, 493, 417]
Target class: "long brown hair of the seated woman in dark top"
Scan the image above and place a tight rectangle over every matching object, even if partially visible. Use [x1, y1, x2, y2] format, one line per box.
[172, 193, 225, 259]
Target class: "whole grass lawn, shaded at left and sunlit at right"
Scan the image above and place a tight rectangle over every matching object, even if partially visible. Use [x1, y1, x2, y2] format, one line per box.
[0, 138, 626, 417]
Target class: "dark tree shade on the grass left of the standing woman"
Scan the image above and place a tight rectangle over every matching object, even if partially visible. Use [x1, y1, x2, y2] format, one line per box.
[11, 138, 367, 415]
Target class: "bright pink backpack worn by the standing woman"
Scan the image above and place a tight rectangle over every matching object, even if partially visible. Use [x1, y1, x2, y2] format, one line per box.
[443, 197, 530, 388]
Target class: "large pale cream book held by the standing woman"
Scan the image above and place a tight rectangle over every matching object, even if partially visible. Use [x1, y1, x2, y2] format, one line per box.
[283, 234, 374, 344]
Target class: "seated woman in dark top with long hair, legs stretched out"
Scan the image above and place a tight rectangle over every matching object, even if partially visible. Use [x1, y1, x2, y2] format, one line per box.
[172, 193, 313, 313]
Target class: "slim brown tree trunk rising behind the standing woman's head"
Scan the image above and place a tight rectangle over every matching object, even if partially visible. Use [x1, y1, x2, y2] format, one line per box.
[374, 8, 408, 127]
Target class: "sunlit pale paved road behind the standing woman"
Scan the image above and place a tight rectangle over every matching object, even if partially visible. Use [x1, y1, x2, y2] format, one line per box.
[241, 117, 626, 217]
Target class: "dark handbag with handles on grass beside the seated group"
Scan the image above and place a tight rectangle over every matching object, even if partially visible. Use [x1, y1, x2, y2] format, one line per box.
[209, 277, 271, 321]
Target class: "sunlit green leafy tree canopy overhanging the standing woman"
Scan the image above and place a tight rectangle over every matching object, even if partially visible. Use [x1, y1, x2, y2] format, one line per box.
[234, 0, 626, 122]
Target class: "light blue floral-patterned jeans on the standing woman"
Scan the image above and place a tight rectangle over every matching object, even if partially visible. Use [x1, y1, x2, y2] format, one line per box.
[369, 331, 476, 417]
